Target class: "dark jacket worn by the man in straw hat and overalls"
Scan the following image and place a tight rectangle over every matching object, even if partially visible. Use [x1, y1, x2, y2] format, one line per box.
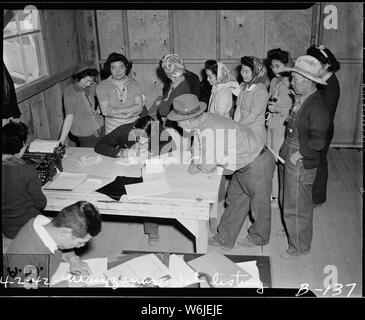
[298, 91, 329, 169]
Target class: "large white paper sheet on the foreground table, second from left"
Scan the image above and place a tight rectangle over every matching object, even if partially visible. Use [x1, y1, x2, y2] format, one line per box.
[105, 254, 172, 288]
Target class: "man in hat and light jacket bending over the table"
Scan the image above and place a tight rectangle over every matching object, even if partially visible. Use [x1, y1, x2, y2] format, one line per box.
[167, 94, 275, 250]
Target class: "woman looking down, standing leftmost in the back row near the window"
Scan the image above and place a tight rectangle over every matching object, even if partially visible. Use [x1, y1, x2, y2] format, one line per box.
[61, 65, 104, 147]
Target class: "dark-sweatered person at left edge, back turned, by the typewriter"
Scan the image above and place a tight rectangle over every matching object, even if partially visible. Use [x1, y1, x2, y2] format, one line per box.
[1, 120, 47, 252]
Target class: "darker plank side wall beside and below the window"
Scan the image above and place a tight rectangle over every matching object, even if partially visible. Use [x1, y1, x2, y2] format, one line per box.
[19, 10, 96, 145]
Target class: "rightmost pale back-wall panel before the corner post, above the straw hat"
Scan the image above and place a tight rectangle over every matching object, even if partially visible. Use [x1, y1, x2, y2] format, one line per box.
[265, 8, 312, 58]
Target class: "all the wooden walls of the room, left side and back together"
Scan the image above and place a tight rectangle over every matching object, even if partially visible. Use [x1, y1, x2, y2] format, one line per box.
[14, 3, 362, 146]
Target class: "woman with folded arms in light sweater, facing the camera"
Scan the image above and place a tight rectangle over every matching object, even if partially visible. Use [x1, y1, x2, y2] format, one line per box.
[96, 52, 143, 134]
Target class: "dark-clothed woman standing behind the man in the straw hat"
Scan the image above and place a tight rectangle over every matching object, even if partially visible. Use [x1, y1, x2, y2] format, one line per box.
[307, 45, 340, 205]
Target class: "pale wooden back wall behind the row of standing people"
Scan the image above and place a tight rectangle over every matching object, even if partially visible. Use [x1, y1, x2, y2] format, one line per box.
[92, 3, 362, 145]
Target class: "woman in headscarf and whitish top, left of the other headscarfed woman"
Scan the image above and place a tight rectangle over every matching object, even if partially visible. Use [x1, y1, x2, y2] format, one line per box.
[204, 60, 239, 118]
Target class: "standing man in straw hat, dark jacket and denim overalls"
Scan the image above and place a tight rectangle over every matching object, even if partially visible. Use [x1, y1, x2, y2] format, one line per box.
[280, 56, 329, 259]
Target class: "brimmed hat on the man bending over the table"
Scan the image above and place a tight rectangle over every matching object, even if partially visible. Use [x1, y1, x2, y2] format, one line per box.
[167, 93, 207, 121]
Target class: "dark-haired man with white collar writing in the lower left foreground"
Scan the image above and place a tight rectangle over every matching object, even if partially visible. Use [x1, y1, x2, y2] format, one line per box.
[7, 201, 101, 285]
